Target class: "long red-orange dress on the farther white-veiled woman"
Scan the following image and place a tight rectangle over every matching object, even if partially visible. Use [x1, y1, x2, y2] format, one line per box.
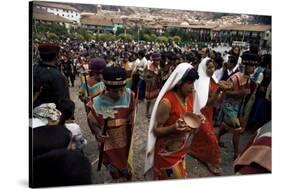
[189, 80, 220, 164]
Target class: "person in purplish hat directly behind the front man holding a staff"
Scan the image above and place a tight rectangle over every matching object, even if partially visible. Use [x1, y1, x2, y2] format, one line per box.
[79, 58, 106, 107]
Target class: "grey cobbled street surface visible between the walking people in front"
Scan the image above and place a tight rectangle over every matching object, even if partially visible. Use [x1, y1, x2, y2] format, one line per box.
[70, 78, 250, 184]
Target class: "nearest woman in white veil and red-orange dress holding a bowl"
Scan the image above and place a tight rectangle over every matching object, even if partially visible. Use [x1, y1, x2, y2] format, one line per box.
[144, 63, 201, 180]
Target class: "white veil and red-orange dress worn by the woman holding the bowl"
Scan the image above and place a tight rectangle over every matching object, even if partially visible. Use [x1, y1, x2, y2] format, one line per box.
[144, 63, 196, 179]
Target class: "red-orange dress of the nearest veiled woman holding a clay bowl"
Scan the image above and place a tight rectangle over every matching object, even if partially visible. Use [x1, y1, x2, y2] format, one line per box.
[153, 91, 193, 180]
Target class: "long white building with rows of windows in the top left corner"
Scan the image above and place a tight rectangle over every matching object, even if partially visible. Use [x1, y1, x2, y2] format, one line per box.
[34, 1, 81, 24]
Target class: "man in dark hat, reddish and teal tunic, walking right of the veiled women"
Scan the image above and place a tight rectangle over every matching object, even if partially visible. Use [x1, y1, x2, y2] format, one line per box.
[218, 52, 258, 159]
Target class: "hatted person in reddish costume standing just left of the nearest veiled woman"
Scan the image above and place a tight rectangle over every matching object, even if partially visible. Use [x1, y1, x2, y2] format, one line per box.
[144, 52, 161, 118]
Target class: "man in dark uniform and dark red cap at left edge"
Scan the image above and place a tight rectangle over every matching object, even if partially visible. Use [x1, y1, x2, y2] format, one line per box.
[33, 43, 69, 107]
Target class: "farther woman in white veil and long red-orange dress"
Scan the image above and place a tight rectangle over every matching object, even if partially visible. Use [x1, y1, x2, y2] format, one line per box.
[189, 58, 221, 175]
